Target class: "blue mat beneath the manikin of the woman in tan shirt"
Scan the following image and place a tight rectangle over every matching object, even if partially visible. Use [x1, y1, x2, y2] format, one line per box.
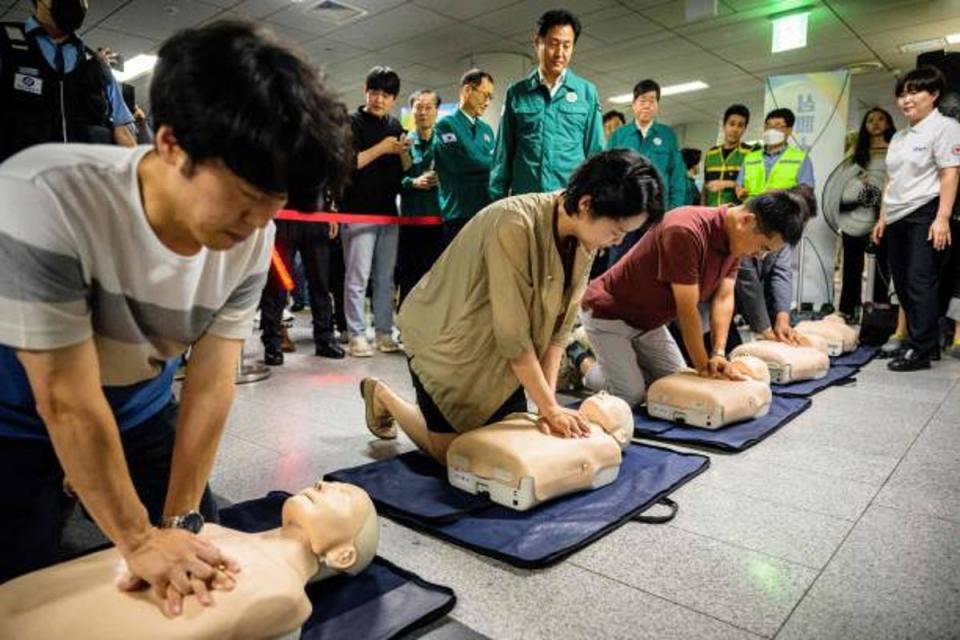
[326, 444, 710, 568]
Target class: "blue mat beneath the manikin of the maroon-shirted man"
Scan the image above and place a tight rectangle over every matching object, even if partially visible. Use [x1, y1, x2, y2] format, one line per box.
[633, 395, 812, 452]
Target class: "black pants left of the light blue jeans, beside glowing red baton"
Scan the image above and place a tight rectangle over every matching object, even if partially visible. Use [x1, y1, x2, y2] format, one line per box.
[260, 220, 333, 350]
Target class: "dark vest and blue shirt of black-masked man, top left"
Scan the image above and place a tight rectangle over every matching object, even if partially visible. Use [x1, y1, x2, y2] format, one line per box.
[0, 17, 133, 162]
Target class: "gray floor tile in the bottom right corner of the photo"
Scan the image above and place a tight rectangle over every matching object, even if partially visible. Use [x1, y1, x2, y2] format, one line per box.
[777, 507, 960, 640]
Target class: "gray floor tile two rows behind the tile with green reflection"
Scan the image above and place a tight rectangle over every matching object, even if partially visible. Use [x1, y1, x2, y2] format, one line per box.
[701, 461, 877, 520]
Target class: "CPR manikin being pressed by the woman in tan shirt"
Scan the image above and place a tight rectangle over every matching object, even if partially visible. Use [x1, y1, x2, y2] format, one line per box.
[447, 392, 633, 511]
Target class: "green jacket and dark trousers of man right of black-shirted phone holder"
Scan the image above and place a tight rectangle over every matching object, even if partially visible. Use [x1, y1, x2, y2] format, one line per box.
[397, 130, 443, 303]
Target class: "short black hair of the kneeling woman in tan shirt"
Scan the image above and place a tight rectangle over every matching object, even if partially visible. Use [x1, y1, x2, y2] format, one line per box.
[563, 149, 664, 224]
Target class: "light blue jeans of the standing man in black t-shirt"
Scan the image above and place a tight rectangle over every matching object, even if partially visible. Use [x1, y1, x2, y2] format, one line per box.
[340, 224, 400, 337]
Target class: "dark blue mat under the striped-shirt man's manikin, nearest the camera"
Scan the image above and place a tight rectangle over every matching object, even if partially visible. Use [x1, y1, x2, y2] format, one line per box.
[220, 491, 457, 640]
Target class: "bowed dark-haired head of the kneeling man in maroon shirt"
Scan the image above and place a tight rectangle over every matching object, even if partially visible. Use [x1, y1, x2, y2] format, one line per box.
[727, 185, 817, 258]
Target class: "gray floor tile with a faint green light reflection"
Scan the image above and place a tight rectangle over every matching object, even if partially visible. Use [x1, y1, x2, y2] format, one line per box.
[571, 524, 817, 637]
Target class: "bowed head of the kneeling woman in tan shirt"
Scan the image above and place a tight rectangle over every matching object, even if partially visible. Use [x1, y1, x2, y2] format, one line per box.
[563, 149, 663, 251]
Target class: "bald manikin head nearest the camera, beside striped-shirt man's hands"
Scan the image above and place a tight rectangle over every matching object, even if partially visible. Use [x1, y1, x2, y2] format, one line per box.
[282, 480, 380, 580]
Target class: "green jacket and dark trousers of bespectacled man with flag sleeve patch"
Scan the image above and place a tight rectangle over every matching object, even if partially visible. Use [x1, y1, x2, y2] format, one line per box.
[434, 109, 495, 246]
